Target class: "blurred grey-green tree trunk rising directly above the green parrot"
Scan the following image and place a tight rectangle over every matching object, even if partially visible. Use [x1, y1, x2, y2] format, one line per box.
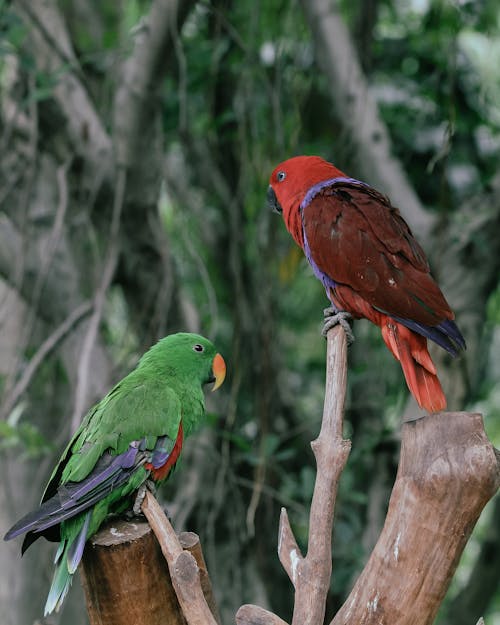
[108, 0, 194, 344]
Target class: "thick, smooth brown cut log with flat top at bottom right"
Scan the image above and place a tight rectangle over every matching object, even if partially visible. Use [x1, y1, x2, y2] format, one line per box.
[331, 412, 500, 625]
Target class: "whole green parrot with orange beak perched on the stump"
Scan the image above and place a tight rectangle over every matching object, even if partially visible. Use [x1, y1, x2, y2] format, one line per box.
[4, 333, 226, 615]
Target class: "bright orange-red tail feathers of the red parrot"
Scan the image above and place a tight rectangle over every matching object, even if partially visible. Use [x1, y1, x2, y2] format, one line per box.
[380, 315, 446, 412]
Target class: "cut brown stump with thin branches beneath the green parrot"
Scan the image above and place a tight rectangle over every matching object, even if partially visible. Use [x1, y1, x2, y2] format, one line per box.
[80, 502, 220, 625]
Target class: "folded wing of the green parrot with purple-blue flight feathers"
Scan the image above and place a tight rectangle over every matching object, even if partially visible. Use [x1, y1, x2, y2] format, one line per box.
[6, 380, 186, 549]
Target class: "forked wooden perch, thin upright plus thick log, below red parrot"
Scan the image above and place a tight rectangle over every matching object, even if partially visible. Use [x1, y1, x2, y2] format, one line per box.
[236, 328, 500, 625]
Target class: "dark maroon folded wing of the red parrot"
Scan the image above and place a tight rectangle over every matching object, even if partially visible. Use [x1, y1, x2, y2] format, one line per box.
[302, 183, 453, 325]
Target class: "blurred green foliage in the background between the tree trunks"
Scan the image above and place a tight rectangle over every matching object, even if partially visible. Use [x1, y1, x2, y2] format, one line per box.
[0, 0, 500, 625]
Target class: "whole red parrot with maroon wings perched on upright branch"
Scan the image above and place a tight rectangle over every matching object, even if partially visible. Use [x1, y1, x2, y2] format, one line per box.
[268, 156, 465, 412]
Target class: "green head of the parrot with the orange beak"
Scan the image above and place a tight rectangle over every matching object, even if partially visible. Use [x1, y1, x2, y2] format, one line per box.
[138, 332, 226, 391]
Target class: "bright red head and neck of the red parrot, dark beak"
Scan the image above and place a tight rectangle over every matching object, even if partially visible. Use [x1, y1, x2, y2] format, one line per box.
[267, 156, 345, 247]
